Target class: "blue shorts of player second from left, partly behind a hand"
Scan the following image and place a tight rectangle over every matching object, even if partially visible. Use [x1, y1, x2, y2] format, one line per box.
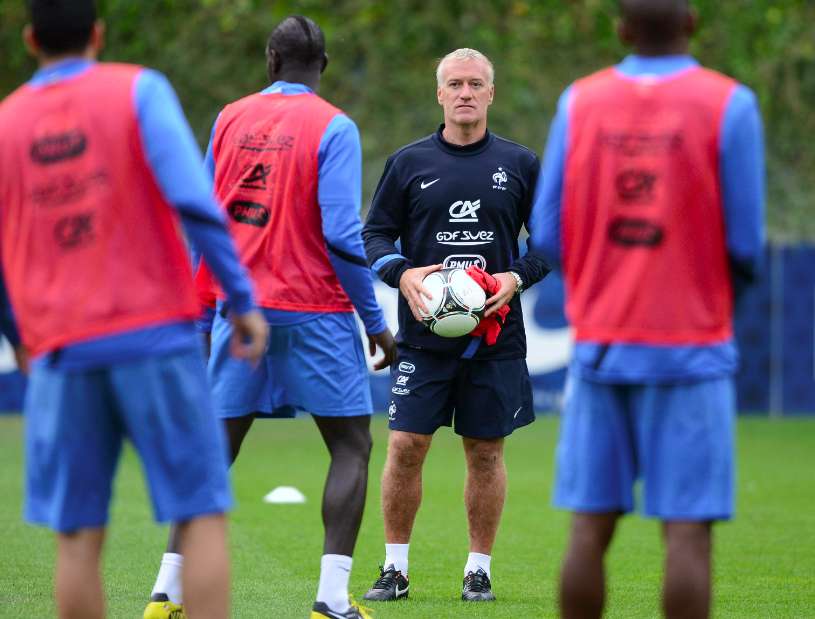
[209, 313, 373, 418]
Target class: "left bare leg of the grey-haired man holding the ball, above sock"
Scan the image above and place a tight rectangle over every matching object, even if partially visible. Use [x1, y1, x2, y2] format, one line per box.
[382, 430, 433, 544]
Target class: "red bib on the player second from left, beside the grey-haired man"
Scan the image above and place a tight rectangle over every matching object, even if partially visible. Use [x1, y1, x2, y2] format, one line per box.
[207, 90, 352, 312]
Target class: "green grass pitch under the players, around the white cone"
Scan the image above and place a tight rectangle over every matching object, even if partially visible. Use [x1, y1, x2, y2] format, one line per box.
[0, 417, 815, 619]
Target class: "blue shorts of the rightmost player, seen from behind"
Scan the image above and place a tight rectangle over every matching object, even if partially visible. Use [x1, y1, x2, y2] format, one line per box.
[554, 376, 736, 521]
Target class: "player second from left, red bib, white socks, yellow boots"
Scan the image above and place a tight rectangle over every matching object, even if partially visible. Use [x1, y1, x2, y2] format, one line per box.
[145, 15, 395, 619]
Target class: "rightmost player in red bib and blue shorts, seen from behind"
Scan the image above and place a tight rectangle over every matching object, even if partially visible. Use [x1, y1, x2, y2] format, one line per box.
[532, 0, 764, 618]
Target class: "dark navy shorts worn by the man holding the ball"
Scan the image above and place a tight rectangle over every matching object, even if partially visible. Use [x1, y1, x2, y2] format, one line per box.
[388, 346, 535, 439]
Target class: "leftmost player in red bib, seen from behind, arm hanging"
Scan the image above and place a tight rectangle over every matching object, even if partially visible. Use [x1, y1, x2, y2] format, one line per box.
[0, 0, 267, 619]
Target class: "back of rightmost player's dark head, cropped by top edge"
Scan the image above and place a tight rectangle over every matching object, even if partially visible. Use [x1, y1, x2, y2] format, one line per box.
[620, 0, 696, 55]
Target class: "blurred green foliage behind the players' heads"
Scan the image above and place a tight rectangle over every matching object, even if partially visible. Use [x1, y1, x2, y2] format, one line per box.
[0, 0, 815, 242]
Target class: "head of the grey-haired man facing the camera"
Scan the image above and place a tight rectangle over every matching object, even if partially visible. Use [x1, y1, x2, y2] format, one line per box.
[436, 58, 495, 125]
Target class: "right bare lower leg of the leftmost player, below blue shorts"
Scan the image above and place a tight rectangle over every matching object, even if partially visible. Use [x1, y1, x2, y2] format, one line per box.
[179, 514, 229, 619]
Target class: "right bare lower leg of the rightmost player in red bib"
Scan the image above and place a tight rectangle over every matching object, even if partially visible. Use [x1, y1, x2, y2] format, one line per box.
[662, 522, 713, 619]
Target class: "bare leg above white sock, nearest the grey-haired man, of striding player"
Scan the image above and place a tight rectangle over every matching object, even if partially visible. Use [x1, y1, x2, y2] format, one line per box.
[314, 415, 372, 557]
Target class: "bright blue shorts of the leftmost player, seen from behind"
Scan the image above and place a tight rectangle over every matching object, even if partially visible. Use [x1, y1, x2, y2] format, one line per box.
[25, 349, 232, 533]
